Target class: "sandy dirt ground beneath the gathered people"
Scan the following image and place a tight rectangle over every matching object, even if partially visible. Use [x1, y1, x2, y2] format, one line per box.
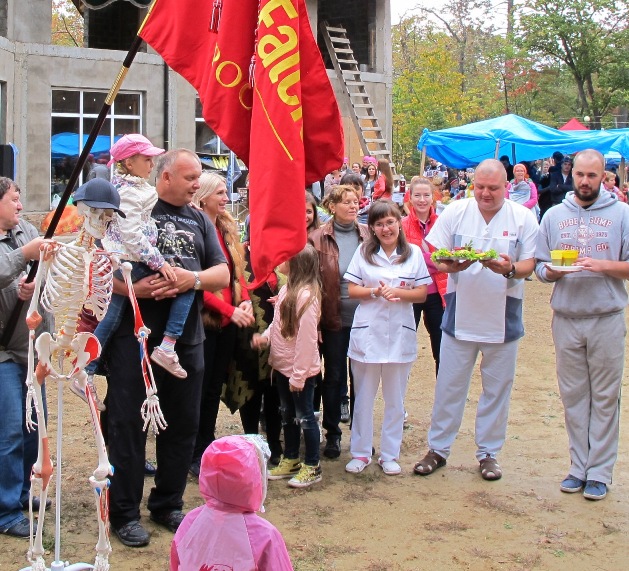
[0, 281, 629, 571]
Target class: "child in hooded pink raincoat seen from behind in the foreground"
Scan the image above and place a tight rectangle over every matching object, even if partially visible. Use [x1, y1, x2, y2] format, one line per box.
[170, 436, 293, 571]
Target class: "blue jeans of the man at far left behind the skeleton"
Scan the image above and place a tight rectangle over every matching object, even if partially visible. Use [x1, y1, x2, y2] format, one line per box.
[0, 361, 46, 530]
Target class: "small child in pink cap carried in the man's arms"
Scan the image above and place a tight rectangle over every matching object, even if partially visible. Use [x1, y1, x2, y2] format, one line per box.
[70, 133, 190, 410]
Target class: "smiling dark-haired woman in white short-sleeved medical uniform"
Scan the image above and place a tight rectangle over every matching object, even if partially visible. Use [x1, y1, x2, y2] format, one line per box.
[345, 200, 431, 475]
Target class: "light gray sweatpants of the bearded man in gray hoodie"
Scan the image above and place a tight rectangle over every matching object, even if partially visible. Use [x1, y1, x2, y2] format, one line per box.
[553, 313, 627, 484]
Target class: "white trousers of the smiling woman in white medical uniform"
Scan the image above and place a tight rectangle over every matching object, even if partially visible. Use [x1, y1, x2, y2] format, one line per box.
[350, 359, 413, 462]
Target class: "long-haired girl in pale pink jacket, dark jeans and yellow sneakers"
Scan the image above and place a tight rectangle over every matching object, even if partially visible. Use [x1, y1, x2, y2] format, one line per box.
[251, 244, 321, 488]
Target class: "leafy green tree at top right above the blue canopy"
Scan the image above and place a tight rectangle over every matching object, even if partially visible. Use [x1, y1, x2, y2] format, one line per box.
[519, 0, 629, 129]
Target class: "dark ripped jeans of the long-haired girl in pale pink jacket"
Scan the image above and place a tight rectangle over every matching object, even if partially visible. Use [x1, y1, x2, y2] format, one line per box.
[273, 371, 320, 466]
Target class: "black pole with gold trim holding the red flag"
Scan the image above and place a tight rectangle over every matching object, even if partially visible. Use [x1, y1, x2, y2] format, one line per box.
[0, 0, 158, 350]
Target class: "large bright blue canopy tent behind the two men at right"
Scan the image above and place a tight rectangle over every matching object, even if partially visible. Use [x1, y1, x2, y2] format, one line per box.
[417, 114, 629, 169]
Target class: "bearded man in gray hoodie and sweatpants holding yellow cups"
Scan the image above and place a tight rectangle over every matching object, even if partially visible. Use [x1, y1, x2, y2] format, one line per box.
[535, 149, 629, 500]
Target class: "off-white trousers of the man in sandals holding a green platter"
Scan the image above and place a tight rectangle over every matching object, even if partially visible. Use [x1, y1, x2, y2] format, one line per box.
[428, 333, 520, 460]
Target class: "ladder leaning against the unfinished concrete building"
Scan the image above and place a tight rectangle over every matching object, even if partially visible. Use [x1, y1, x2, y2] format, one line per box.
[319, 22, 391, 163]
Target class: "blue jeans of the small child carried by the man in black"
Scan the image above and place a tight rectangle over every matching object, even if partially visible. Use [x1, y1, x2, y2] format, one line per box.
[85, 263, 195, 375]
